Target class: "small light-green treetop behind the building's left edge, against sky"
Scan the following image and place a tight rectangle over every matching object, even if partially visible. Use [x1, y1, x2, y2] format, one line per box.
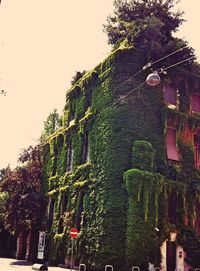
[41, 109, 62, 139]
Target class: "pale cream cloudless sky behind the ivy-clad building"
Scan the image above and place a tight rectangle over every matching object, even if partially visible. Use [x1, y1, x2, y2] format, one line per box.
[0, 0, 200, 168]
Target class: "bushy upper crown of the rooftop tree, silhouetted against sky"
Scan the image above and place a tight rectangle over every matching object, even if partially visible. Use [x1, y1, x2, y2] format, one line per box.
[104, 0, 184, 47]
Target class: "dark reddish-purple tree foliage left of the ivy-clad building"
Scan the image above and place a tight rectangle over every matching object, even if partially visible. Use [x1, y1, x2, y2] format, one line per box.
[1, 146, 44, 233]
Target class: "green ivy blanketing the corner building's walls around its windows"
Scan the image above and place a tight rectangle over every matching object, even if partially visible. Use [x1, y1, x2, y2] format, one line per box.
[43, 47, 200, 270]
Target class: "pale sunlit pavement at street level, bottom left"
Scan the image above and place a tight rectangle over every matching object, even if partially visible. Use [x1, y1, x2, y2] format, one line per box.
[0, 258, 77, 271]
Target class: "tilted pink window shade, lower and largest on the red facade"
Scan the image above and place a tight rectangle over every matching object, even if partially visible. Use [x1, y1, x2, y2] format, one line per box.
[166, 128, 179, 161]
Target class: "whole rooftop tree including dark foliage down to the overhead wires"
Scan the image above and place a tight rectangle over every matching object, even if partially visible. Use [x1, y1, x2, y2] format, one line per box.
[104, 0, 195, 70]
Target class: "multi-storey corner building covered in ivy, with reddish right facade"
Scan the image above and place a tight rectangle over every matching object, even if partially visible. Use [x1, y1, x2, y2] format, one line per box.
[42, 47, 200, 271]
